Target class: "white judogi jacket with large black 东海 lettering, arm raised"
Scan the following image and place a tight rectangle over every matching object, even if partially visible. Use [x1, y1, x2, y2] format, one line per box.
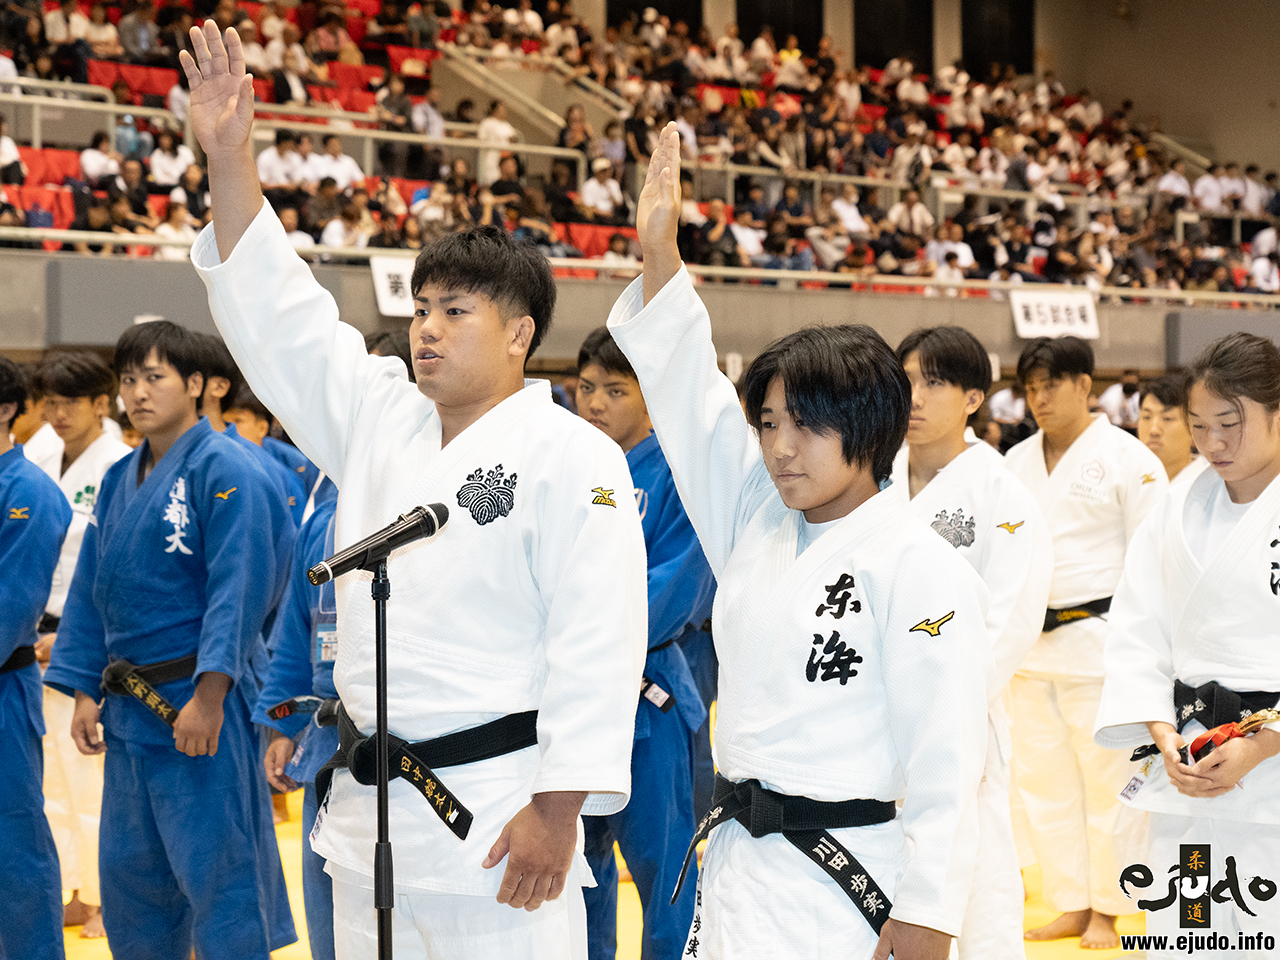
[609, 270, 991, 934]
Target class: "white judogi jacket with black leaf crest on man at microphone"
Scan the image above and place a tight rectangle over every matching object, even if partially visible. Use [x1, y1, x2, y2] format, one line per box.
[192, 204, 646, 896]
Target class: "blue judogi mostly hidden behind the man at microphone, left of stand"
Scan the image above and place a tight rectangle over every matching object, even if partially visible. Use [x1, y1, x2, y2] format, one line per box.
[253, 500, 338, 960]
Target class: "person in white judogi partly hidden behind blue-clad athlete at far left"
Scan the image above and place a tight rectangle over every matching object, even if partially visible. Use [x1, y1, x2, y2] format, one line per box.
[32, 352, 131, 937]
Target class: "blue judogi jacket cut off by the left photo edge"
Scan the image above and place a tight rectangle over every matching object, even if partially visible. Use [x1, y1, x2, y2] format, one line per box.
[0, 447, 72, 736]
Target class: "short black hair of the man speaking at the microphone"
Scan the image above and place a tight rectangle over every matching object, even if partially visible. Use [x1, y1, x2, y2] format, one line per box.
[410, 227, 556, 360]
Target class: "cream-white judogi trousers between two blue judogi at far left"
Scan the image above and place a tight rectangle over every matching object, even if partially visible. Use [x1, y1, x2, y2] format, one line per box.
[44, 686, 104, 906]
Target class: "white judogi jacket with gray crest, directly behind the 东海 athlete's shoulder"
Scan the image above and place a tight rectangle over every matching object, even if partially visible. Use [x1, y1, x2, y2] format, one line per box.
[890, 442, 1053, 763]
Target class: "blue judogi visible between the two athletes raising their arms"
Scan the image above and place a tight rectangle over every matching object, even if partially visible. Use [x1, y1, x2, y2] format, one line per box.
[582, 434, 714, 960]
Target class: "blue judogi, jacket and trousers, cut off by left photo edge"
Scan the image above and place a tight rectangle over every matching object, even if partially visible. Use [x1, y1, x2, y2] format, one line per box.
[0, 450, 72, 960]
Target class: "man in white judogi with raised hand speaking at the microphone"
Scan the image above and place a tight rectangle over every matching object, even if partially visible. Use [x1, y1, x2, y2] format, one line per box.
[183, 22, 646, 960]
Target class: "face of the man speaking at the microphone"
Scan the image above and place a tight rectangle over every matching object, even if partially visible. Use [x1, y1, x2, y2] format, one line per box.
[408, 285, 534, 406]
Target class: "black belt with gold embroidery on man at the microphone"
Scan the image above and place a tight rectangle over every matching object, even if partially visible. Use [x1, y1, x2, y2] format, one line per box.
[316, 704, 538, 840]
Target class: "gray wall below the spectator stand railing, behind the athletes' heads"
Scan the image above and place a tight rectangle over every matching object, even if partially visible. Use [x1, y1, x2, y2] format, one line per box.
[0, 251, 1172, 370]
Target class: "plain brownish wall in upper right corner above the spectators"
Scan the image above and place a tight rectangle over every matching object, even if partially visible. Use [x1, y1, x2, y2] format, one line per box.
[1036, 0, 1280, 169]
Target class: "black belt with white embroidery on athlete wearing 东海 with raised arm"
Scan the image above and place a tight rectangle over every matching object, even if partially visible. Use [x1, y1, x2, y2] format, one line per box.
[671, 774, 897, 933]
